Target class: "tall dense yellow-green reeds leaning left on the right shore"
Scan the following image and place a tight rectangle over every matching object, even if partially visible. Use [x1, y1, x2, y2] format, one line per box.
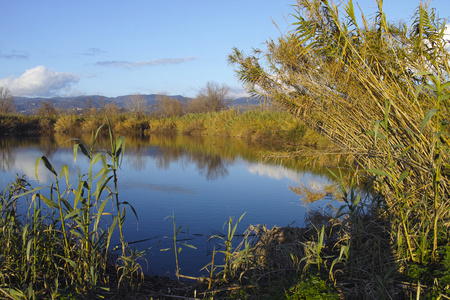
[229, 0, 450, 299]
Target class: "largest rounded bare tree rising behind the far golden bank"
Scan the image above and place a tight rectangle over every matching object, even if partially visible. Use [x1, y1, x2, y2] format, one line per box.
[187, 81, 230, 113]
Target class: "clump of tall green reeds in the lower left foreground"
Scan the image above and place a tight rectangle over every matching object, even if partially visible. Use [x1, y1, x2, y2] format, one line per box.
[0, 122, 144, 298]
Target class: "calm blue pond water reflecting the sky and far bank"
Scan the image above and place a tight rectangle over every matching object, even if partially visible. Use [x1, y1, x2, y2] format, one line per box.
[0, 136, 331, 276]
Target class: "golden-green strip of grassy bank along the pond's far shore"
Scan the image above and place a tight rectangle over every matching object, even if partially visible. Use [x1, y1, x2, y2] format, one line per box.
[0, 109, 330, 148]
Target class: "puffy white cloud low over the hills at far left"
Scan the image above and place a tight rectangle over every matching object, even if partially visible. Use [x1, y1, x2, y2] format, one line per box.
[0, 66, 79, 97]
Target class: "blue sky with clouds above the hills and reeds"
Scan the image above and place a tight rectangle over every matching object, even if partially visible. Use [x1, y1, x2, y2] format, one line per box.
[0, 0, 450, 97]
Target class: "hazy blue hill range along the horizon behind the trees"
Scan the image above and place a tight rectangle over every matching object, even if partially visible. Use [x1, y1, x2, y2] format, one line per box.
[14, 94, 259, 115]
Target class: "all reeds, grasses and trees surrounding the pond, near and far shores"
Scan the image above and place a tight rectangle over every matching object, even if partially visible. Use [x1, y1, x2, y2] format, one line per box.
[0, 0, 450, 299]
